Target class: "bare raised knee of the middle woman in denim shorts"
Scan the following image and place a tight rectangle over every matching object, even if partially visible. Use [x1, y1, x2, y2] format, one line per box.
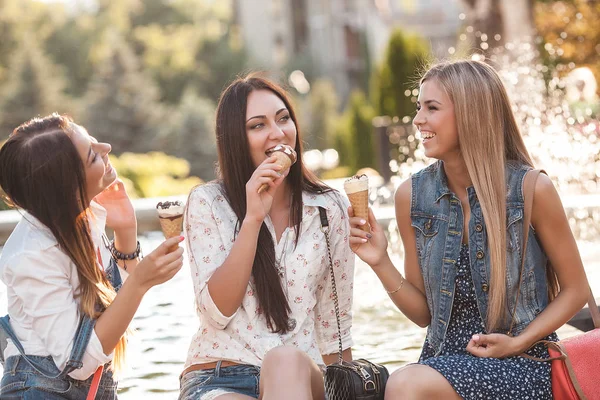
[260, 346, 325, 400]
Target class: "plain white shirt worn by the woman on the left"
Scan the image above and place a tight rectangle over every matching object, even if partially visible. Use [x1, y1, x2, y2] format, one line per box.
[0, 202, 113, 380]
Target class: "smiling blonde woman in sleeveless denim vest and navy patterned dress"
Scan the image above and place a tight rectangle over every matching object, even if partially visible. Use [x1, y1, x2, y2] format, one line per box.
[350, 61, 589, 399]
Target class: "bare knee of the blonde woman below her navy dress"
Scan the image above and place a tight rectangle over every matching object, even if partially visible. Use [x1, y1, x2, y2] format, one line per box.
[385, 364, 461, 400]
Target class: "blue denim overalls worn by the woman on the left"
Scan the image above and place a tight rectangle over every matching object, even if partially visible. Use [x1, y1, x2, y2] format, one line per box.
[0, 260, 122, 400]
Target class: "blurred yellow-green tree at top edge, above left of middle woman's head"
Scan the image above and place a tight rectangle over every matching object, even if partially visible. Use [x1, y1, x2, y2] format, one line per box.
[132, 0, 247, 104]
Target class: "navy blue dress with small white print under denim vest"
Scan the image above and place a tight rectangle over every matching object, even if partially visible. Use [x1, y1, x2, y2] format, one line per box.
[419, 244, 558, 400]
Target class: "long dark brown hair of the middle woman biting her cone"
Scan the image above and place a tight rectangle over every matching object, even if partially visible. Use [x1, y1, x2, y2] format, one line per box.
[215, 74, 331, 333]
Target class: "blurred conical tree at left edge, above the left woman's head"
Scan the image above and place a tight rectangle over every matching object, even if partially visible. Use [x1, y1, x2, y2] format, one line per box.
[0, 40, 69, 137]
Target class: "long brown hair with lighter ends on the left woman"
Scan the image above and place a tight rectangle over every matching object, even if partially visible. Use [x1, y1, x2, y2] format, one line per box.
[0, 114, 126, 369]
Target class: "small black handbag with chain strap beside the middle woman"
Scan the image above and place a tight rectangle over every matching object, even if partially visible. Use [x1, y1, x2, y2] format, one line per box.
[319, 207, 390, 400]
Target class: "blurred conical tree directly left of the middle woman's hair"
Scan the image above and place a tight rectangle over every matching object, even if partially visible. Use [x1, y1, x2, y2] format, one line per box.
[159, 88, 217, 180]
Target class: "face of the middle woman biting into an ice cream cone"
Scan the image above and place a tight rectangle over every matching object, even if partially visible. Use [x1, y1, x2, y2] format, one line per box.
[246, 90, 297, 168]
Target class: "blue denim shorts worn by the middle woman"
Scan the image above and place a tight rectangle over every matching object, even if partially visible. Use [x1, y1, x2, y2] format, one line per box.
[179, 361, 260, 400]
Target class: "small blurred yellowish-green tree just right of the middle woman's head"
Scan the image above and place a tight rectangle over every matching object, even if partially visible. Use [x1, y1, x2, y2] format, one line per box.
[304, 80, 339, 150]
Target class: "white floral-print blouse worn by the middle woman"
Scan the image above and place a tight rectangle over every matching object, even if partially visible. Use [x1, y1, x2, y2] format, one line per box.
[184, 182, 354, 367]
